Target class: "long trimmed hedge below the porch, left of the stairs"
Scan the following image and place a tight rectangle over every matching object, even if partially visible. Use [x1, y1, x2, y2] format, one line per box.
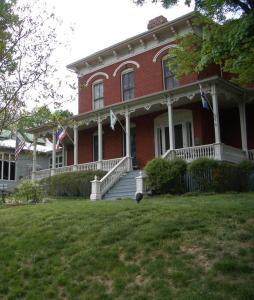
[40, 171, 106, 198]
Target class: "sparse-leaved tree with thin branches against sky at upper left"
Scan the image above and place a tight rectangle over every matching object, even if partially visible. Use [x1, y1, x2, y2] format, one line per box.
[0, 0, 71, 132]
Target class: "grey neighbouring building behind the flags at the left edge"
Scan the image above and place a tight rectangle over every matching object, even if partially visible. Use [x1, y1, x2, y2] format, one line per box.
[0, 130, 63, 190]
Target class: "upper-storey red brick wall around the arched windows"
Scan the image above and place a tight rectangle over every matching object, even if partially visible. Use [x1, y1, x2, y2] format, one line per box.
[79, 46, 202, 113]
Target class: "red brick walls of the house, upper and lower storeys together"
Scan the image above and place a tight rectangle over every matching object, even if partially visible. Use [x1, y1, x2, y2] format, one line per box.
[67, 39, 254, 167]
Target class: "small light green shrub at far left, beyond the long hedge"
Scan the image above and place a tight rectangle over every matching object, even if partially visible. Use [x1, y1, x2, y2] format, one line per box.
[13, 179, 43, 203]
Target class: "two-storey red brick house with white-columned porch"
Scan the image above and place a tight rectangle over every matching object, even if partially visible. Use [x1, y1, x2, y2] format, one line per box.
[29, 13, 254, 199]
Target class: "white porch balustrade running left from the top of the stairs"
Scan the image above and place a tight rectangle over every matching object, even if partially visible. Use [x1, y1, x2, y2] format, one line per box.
[33, 158, 122, 180]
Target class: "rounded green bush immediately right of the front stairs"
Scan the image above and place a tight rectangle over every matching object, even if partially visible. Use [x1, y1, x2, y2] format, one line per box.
[145, 158, 186, 194]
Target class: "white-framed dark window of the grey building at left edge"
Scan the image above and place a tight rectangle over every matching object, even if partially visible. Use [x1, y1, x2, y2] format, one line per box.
[0, 153, 16, 180]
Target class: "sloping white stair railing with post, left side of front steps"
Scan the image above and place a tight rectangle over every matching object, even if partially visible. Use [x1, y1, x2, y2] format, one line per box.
[90, 157, 132, 200]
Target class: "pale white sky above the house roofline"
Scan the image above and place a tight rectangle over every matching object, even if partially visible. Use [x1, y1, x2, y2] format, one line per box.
[45, 0, 192, 114]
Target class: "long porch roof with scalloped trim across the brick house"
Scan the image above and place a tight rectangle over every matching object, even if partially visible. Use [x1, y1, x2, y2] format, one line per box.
[27, 76, 254, 134]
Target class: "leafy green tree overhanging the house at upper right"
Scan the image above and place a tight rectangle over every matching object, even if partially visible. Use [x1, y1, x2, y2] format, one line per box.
[134, 0, 254, 85]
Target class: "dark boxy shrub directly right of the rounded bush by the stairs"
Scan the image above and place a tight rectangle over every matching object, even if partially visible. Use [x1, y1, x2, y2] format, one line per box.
[188, 158, 219, 192]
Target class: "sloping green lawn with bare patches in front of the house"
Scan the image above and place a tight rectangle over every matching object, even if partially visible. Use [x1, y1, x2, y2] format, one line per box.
[0, 193, 254, 300]
